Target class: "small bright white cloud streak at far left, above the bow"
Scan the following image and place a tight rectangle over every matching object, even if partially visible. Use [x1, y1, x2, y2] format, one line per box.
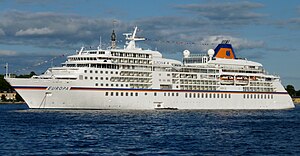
[16, 27, 54, 36]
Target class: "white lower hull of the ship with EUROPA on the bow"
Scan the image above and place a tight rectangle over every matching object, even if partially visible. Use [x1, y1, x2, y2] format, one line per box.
[6, 78, 294, 110]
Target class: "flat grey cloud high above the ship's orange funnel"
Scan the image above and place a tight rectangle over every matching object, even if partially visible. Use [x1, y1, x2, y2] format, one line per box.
[175, 2, 266, 27]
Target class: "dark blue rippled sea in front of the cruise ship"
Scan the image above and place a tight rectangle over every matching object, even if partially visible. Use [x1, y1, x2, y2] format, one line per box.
[0, 104, 300, 156]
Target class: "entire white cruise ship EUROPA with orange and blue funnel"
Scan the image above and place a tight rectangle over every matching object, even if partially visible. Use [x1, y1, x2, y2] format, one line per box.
[5, 27, 295, 110]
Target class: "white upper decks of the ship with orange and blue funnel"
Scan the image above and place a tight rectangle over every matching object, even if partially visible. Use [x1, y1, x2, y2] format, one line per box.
[27, 26, 279, 91]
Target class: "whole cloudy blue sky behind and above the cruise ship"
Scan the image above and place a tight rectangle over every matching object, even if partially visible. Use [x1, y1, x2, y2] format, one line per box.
[0, 0, 300, 90]
